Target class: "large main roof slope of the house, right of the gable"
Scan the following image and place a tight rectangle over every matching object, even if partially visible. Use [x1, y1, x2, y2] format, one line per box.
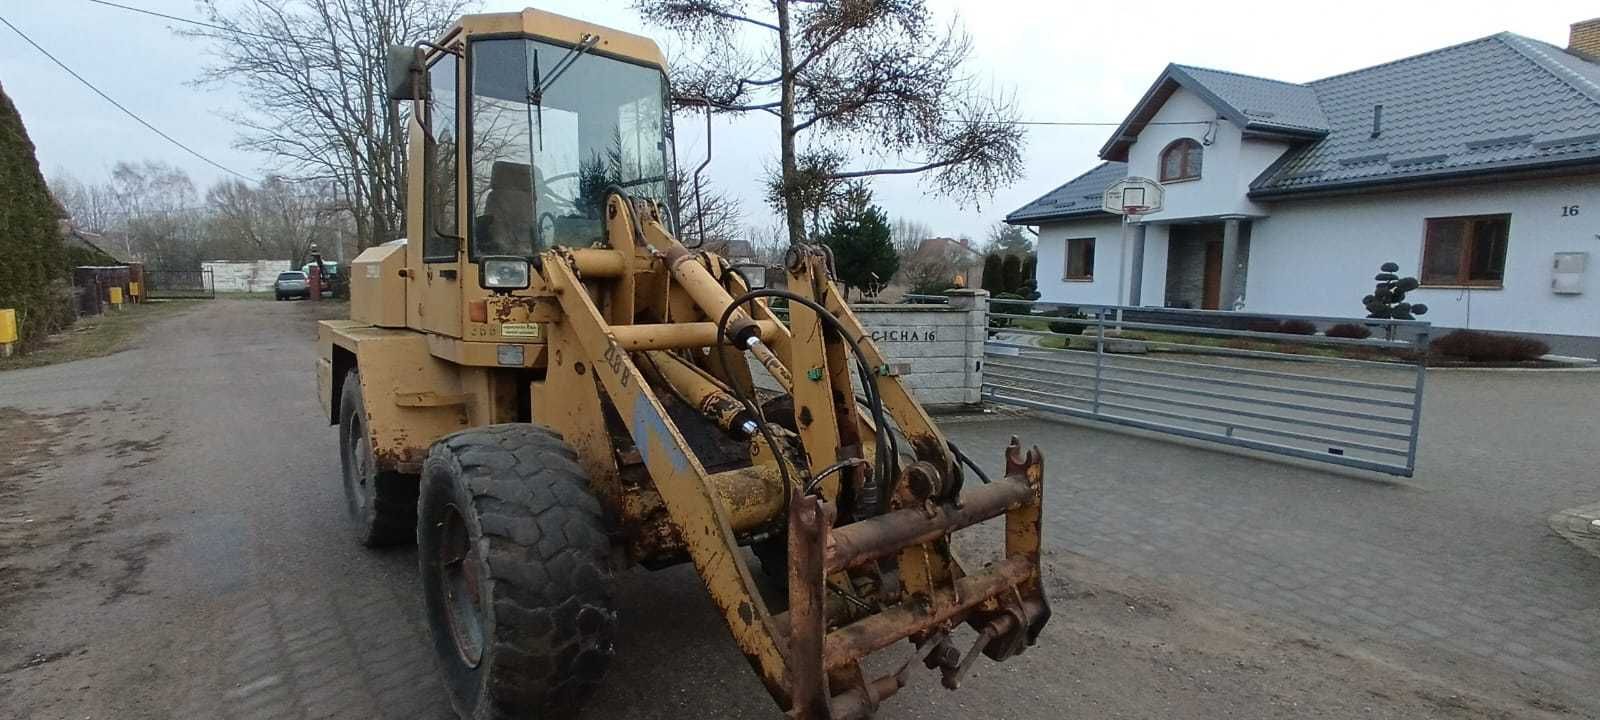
[1251, 32, 1600, 197]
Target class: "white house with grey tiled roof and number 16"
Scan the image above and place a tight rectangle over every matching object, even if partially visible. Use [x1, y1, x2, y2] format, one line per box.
[1006, 19, 1600, 355]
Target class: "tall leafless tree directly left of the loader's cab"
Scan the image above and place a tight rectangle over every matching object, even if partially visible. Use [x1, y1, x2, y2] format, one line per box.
[184, 0, 467, 248]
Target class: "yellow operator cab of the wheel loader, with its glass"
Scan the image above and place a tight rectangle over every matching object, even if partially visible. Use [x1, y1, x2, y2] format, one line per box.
[389, 10, 672, 339]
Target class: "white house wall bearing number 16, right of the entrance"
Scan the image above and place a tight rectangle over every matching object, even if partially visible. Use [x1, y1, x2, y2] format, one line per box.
[1245, 176, 1600, 336]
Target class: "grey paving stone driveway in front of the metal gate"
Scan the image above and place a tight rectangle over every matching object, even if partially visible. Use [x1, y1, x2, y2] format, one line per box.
[946, 371, 1600, 694]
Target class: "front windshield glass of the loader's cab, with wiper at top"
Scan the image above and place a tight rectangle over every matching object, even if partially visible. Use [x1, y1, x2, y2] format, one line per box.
[469, 38, 669, 258]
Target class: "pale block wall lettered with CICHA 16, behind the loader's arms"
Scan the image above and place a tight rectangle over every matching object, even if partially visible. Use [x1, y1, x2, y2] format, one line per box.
[750, 290, 989, 408]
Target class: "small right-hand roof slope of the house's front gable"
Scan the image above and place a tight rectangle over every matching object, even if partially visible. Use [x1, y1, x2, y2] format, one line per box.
[1170, 66, 1328, 134]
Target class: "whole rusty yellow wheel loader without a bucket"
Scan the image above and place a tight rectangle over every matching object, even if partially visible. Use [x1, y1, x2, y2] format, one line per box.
[317, 10, 1050, 718]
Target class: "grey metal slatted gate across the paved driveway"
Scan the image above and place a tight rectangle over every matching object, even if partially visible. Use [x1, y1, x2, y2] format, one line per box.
[982, 299, 1429, 477]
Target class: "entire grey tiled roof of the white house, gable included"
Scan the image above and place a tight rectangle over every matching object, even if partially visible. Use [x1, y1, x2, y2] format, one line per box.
[1006, 32, 1600, 222]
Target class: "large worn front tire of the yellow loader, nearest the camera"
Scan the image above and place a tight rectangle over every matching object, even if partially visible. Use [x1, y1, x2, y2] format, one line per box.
[416, 424, 616, 720]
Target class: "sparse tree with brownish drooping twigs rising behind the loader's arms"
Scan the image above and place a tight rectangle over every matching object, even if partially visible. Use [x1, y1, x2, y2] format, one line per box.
[634, 0, 1022, 242]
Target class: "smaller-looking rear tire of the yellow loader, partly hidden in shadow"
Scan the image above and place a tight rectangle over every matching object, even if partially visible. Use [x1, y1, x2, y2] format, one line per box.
[339, 368, 416, 547]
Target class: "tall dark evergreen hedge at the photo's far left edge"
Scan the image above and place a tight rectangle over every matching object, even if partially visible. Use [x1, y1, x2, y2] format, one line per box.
[0, 81, 72, 352]
